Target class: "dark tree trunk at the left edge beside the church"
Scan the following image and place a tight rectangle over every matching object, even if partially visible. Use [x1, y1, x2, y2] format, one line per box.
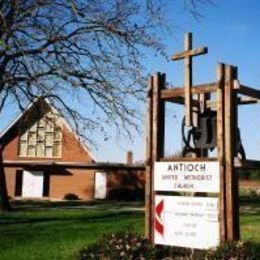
[0, 142, 11, 211]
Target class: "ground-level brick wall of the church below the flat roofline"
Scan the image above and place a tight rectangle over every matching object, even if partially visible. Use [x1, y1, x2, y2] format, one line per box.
[5, 167, 145, 200]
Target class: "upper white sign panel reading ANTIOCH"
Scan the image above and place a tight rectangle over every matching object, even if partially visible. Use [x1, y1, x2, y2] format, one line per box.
[154, 161, 220, 192]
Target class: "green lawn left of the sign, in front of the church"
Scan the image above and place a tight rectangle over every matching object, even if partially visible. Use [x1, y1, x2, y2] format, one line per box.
[0, 204, 144, 260]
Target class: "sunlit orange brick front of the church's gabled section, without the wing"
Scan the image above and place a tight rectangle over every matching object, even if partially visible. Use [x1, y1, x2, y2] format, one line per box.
[3, 117, 94, 200]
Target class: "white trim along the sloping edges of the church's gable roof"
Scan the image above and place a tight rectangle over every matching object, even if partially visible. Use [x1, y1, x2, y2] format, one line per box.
[0, 98, 96, 161]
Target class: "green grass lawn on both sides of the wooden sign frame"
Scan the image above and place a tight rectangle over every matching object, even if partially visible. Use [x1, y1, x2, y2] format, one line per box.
[0, 199, 260, 260]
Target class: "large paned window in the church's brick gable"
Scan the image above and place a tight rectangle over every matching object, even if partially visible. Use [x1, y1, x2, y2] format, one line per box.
[18, 112, 62, 158]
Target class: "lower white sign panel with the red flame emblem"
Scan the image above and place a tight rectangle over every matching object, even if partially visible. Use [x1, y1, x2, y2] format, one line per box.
[154, 195, 220, 249]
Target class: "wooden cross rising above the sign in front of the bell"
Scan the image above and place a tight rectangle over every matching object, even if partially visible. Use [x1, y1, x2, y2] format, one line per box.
[171, 33, 208, 126]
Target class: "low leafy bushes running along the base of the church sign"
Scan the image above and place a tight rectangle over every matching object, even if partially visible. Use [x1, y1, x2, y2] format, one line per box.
[77, 232, 260, 260]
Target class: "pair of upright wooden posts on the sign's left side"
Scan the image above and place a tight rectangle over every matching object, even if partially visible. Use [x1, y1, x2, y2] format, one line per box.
[146, 73, 165, 242]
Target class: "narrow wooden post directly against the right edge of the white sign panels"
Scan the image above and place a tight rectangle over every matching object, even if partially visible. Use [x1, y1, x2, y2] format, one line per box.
[216, 64, 227, 242]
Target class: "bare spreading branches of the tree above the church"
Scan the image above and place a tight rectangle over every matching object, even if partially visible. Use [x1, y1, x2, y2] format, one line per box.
[0, 0, 211, 210]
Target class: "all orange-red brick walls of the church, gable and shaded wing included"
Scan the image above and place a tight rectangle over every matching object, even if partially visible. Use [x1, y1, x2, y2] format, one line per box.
[2, 98, 144, 200]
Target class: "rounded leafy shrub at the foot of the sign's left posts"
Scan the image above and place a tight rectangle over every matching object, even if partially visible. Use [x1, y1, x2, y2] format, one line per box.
[77, 232, 155, 260]
